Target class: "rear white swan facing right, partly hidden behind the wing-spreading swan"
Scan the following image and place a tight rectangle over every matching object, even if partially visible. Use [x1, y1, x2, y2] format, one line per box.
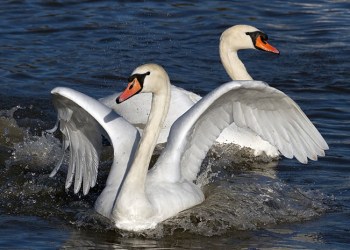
[100, 25, 279, 157]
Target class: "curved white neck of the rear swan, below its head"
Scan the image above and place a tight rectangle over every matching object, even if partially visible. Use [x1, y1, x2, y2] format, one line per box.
[220, 41, 253, 80]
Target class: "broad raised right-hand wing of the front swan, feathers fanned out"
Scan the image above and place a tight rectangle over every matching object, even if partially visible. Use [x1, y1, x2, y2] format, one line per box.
[154, 81, 328, 181]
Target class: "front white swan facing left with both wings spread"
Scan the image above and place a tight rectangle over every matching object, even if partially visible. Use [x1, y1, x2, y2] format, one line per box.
[51, 64, 328, 231]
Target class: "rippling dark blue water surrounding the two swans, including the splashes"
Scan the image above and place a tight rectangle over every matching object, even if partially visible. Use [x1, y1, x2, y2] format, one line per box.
[0, 0, 350, 249]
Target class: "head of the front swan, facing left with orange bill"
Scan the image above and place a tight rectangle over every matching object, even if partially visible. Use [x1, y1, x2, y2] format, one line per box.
[116, 63, 170, 103]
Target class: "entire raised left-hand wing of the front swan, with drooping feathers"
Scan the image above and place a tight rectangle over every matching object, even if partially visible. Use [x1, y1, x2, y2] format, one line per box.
[50, 87, 139, 194]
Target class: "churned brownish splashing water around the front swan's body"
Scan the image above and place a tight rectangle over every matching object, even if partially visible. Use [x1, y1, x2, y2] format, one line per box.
[0, 107, 331, 238]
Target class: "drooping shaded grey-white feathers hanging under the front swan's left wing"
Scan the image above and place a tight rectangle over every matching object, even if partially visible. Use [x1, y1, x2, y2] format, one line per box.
[50, 91, 102, 194]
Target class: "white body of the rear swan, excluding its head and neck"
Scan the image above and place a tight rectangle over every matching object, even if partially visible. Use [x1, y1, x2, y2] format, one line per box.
[99, 85, 278, 157]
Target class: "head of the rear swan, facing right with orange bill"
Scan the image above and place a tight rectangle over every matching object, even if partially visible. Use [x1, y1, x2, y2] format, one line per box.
[220, 25, 280, 54]
